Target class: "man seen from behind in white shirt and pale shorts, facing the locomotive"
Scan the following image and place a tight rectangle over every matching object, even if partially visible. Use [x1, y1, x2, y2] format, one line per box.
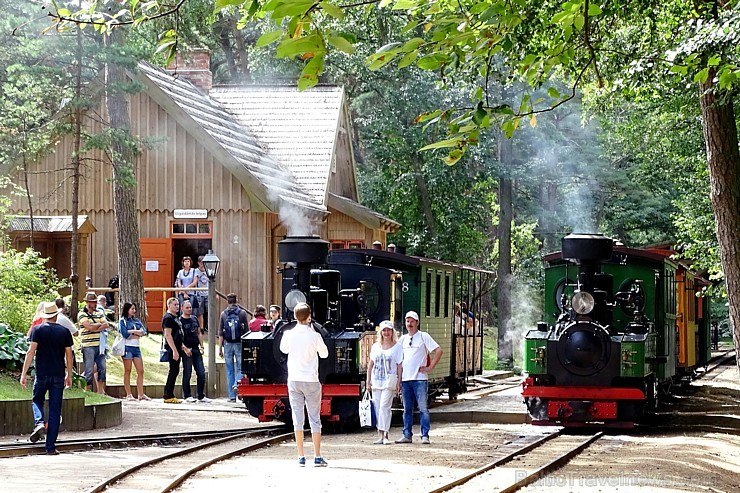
[280, 303, 329, 466]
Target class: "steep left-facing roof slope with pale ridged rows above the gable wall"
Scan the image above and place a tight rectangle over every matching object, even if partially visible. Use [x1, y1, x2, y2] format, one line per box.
[136, 62, 326, 213]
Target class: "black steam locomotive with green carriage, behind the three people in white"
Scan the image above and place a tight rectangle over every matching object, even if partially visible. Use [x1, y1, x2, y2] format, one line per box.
[237, 237, 487, 422]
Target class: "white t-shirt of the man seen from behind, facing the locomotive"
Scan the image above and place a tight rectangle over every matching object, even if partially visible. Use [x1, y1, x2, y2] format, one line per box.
[280, 324, 329, 382]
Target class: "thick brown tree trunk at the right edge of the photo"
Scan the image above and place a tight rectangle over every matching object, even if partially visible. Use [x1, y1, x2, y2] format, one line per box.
[699, 76, 740, 371]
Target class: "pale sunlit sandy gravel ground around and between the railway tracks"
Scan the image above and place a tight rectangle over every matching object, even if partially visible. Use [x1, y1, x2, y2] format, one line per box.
[0, 360, 740, 493]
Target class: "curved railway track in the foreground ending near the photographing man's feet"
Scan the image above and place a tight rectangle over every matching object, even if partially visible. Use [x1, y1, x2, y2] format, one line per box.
[87, 427, 293, 493]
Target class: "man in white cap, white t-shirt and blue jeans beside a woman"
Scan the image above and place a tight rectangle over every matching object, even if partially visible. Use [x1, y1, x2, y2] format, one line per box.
[396, 311, 442, 444]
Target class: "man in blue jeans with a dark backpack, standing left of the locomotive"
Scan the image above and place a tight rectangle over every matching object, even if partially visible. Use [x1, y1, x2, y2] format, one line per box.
[218, 293, 249, 402]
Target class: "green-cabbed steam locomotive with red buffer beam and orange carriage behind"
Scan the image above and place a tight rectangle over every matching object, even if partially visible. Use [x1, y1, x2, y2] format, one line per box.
[523, 235, 710, 426]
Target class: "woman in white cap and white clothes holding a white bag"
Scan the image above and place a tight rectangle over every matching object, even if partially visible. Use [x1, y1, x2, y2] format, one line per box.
[367, 320, 403, 445]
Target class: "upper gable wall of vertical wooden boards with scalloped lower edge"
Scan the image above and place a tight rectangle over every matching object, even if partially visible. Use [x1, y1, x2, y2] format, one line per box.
[12, 93, 250, 215]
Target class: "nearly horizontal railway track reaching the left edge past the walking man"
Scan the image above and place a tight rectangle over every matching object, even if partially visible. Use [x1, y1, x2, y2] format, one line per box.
[0, 425, 283, 458]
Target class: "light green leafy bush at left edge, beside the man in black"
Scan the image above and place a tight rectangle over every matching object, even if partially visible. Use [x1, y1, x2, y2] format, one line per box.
[0, 249, 65, 332]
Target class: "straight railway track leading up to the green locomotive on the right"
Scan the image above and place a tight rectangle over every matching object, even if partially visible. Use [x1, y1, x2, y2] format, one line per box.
[429, 429, 603, 493]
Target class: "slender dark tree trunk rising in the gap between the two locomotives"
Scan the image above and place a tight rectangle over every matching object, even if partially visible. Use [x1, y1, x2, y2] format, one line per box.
[497, 132, 514, 368]
